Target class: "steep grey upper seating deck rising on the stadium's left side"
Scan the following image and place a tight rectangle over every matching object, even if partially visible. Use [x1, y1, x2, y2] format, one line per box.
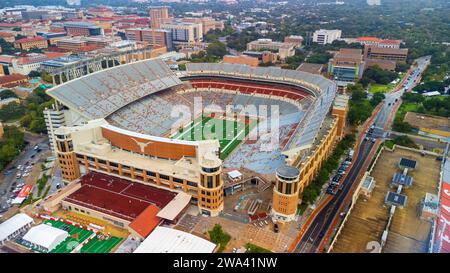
[47, 59, 181, 119]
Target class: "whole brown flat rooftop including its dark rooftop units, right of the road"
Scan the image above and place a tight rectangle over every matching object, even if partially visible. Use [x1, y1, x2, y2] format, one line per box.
[331, 147, 440, 253]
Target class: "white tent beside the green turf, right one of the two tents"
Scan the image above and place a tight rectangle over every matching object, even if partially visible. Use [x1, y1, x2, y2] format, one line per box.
[22, 224, 69, 251]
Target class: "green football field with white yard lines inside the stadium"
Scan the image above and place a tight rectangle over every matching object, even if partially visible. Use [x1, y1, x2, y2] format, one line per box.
[172, 113, 257, 159]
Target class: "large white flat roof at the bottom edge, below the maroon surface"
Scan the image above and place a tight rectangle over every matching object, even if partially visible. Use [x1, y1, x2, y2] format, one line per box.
[134, 227, 216, 253]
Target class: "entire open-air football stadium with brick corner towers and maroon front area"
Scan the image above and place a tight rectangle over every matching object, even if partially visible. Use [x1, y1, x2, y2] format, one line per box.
[44, 59, 347, 223]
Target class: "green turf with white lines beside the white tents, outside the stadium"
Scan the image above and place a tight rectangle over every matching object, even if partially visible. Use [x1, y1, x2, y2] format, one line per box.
[44, 220, 122, 253]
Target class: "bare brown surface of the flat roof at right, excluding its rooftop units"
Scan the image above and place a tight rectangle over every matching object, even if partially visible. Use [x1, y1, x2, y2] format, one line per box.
[332, 148, 440, 253]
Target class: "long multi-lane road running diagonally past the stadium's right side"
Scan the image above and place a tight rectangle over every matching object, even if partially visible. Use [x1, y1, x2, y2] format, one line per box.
[294, 56, 430, 253]
